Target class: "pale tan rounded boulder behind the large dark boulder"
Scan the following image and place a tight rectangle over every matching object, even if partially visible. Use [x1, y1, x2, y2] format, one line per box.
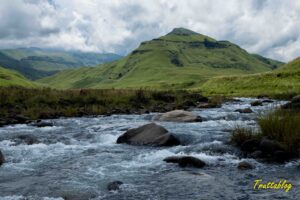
[155, 110, 202, 122]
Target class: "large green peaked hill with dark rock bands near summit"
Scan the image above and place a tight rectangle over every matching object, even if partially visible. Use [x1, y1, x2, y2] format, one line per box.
[39, 28, 282, 89]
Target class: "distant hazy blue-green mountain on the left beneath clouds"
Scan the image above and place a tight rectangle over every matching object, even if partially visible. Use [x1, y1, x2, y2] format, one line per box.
[0, 48, 121, 80]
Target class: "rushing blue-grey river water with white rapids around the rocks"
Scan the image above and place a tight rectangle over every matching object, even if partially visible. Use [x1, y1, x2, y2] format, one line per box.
[0, 98, 300, 200]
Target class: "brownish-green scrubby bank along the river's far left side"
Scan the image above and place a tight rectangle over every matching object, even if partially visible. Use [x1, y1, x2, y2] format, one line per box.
[0, 87, 207, 122]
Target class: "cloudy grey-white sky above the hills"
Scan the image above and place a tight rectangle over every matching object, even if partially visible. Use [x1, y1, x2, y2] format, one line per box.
[0, 0, 300, 61]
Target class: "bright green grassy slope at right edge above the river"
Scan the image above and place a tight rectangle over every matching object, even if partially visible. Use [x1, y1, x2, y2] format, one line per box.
[201, 58, 300, 97]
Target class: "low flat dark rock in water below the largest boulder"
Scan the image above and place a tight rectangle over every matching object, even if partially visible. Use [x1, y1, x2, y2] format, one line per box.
[164, 156, 206, 168]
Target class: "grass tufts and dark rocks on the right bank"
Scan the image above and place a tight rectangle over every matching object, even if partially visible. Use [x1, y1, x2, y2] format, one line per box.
[231, 109, 300, 162]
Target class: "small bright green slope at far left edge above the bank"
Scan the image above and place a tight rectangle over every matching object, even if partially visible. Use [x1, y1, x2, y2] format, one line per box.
[0, 67, 38, 88]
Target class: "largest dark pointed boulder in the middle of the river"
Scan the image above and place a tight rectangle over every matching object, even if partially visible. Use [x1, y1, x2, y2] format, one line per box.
[117, 123, 180, 146]
